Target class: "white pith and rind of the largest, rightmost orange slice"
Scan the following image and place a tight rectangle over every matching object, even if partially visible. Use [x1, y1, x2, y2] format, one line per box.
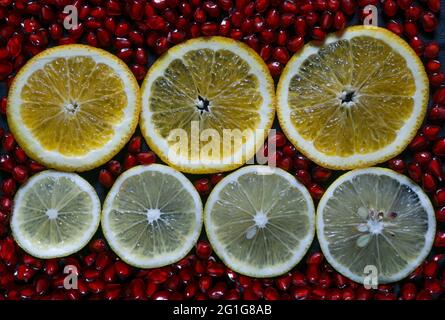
[277, 26, 428, 169]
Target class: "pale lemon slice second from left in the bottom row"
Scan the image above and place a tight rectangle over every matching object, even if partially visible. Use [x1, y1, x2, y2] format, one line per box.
[102, 164, 202, 268]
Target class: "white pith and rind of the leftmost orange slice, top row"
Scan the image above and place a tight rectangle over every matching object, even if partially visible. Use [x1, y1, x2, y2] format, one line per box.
[8, 45, 140, 171]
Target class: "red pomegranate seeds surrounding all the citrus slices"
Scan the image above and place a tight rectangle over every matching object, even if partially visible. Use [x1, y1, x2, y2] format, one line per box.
[0, 0, 445, 300]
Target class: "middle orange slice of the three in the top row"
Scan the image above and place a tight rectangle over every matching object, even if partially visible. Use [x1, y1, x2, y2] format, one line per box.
[140, 37, 275, 173]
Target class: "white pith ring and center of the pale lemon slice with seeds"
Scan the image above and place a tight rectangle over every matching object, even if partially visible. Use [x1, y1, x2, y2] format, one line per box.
[317, 167, 436, 283]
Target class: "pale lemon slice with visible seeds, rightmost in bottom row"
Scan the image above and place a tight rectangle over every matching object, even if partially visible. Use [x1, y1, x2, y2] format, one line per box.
[317, 168, 436, 283]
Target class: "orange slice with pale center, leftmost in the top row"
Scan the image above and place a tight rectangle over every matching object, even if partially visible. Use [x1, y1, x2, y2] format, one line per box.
[7, 44, 140, 171]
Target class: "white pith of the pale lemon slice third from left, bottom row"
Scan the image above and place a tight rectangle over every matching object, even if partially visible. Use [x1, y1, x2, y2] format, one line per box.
[204, 165, 315, 278]
